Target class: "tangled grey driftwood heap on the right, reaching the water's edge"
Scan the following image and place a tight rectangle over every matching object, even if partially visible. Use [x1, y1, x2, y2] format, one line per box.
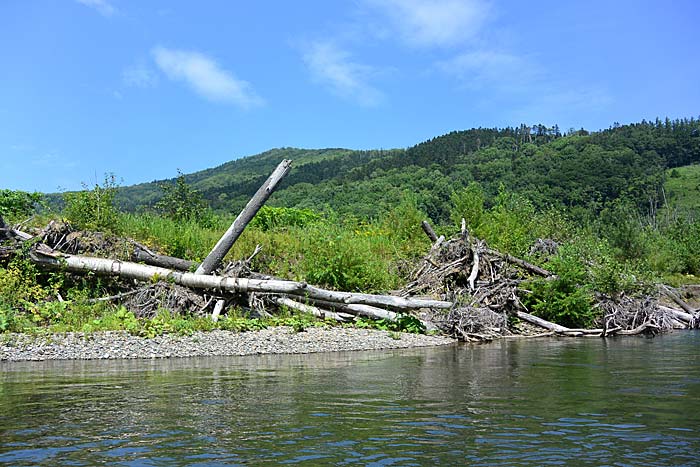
[402, 221, 700, 341]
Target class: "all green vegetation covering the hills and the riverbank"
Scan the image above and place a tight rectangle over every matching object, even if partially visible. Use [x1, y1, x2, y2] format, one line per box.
[5, 119, 700, 335]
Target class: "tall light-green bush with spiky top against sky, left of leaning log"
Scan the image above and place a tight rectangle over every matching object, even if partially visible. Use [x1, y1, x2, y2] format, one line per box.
[63, 174, 119, 233]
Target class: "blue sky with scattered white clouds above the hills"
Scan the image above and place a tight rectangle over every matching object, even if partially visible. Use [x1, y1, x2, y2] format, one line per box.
[0, 0, 700, 192]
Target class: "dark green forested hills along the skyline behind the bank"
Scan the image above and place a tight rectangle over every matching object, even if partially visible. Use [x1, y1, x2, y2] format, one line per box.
[119, 118, 700, 222]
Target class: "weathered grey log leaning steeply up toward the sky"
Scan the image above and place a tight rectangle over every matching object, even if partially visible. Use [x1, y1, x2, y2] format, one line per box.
[196, 159, 292, 274]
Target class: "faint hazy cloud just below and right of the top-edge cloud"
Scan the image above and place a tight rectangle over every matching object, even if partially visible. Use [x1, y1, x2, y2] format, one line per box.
[436, 50, 540, 90]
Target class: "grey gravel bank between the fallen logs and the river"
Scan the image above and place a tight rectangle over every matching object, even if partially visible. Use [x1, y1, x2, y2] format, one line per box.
[0, 327, 455, 361]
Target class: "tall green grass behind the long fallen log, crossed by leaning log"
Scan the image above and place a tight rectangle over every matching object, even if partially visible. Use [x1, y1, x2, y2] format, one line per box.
[118, 208, 429, 291]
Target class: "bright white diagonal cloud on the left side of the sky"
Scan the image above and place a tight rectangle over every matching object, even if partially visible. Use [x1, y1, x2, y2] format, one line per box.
[152, 47, 263, 108]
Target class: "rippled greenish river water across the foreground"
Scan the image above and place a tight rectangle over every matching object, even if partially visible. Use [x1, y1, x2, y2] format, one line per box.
[0, 332, 700, 466]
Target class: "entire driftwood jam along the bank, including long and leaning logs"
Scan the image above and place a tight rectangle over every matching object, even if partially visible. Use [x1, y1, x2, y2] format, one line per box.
[0, 160, 700, 341]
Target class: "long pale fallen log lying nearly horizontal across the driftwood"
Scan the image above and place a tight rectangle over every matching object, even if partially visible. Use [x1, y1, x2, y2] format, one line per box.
[31, 248, 452, 310]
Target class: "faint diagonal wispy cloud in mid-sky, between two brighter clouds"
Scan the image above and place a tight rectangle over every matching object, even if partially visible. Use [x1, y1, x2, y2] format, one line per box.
[303, 42, 384, 107]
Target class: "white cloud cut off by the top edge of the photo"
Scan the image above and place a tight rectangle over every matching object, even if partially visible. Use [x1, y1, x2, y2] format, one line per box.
[366, 0, 491, 47]
